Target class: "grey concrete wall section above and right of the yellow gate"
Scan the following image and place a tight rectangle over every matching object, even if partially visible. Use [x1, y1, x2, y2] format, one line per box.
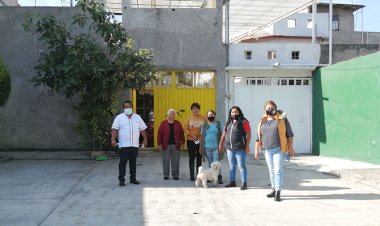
[123, 6, 226, 120]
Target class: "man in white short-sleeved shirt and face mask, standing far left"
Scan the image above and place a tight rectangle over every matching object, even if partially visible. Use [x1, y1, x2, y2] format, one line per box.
[111, 100, 148, 186]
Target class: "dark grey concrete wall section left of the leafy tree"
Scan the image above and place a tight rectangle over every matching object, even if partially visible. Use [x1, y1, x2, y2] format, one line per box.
[0, 7, 90, 150]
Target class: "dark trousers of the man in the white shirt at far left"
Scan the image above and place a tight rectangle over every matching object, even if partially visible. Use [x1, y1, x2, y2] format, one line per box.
[119, 147, 138, 182]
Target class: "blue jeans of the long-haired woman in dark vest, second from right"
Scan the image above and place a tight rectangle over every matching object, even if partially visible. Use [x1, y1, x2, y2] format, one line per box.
[227, 149, 247, 183]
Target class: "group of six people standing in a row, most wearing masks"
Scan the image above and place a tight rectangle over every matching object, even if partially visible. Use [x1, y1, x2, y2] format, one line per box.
[111, 101, 295, 201]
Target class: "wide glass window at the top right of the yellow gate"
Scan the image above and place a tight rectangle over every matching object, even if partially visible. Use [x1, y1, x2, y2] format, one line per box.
[176, 71, 215, 88]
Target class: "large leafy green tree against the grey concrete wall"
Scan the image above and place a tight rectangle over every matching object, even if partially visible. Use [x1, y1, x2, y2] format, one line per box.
[23, 0, 155, 150]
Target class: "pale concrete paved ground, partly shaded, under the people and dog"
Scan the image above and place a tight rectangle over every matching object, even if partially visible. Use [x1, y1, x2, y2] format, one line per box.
[0, 151, 380, 226]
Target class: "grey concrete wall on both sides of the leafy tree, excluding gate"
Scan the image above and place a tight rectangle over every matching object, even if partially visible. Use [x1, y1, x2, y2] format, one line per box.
[0, 4, 226, 150]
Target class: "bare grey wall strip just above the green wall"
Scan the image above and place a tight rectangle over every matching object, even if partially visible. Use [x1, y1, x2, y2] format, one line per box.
[320, 44, 380, 64]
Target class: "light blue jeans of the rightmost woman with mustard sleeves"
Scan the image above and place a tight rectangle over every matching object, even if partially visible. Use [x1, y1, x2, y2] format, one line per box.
[265, 147, 285, 191]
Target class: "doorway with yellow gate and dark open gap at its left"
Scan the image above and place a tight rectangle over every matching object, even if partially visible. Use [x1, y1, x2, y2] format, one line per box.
[133, 70, 216, 148]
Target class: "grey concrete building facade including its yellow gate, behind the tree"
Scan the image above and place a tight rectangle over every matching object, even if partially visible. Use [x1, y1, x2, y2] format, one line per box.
[0, 1, 226, 150]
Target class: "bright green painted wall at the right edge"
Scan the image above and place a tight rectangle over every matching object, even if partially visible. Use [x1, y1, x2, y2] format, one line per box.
[313, 53, 380, 164]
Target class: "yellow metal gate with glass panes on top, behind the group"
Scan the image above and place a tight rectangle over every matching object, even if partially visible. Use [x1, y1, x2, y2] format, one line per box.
[135, 71, 216, 148]
